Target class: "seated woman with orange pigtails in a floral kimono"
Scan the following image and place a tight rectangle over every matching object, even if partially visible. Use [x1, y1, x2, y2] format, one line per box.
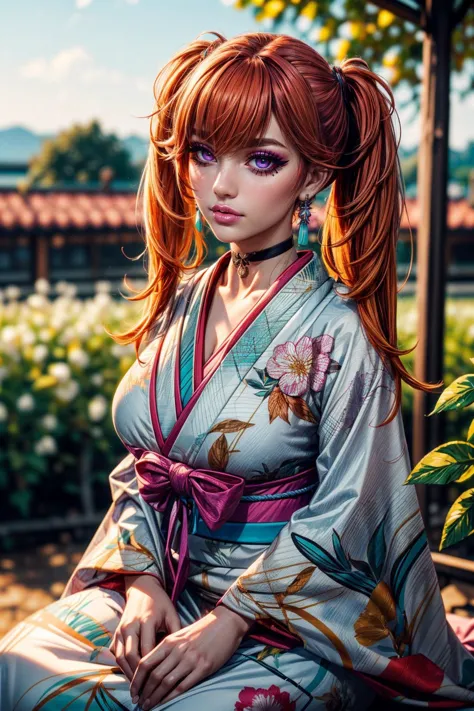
[1, 33, 474, 711]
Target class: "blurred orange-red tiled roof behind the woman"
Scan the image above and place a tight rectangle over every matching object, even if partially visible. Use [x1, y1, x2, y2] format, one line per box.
[0, 190, 474, 232]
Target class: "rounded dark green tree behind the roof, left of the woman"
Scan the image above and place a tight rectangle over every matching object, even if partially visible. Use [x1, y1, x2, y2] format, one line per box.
[26, 120, 138, 187]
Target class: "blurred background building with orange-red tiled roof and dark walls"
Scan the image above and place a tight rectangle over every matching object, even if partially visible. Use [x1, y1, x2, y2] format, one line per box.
[0, 171, 474, 296]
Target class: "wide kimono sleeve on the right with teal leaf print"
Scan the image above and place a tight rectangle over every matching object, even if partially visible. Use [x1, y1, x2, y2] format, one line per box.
[218, 312, 474, 698]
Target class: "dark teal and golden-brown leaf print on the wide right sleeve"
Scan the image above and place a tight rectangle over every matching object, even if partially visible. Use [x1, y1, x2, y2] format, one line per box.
[291, 516, 429, 657]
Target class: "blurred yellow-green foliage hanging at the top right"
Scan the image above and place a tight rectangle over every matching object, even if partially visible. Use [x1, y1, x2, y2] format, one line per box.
[226, 0, 474, 111]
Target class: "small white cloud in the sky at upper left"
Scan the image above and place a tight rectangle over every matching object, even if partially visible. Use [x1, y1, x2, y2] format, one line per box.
[20, 46, 126, 85]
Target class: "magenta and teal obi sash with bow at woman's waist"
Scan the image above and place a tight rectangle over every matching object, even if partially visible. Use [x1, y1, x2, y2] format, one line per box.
[134, 450, 318, 603]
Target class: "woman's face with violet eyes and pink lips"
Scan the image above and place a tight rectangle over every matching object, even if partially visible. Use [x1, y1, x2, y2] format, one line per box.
[189, 115, 314, 250]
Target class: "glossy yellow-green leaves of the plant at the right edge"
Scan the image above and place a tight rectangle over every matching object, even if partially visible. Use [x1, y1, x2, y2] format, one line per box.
[405, 358, 474, 550]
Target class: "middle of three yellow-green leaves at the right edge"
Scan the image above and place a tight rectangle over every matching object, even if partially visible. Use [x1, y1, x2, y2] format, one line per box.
[404, 441, 474, 484]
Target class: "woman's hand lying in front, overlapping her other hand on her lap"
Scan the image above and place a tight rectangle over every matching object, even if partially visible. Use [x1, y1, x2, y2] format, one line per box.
[130, 605, 253, 711]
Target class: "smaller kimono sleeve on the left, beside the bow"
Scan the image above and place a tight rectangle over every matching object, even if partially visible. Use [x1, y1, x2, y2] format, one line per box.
[62, 453, 165, 597]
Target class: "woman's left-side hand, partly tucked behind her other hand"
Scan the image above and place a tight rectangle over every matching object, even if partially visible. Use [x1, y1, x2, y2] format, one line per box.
[110, 575, 181, 681]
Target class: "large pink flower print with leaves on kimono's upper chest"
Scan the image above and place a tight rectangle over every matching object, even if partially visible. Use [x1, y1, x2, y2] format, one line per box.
[246, 333, 341, 424]
